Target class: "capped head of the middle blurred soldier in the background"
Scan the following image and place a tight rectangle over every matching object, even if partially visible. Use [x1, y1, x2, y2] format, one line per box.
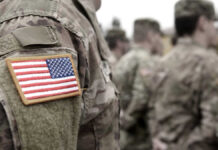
[134, 19, 163, 53]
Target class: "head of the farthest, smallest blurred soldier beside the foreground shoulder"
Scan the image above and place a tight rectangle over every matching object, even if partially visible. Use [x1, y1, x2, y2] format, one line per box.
[105, 28, 129, 58]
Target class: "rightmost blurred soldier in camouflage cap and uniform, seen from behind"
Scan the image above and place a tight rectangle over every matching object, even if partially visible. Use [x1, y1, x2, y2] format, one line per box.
[149, 0, 218, 150]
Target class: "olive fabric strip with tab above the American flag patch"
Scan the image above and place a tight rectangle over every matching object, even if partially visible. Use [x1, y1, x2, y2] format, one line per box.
[0, 26, 59, 55]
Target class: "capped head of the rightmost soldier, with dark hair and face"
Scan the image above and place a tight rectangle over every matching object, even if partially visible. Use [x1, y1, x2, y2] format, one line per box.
[175, 0, 217, 46]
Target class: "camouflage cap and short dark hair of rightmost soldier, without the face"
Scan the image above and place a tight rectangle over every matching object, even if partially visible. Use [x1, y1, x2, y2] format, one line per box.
[175, 0, 216, 37]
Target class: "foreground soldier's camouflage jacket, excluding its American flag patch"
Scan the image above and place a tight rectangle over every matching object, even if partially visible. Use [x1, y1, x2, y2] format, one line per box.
[0, 0, 119, 150]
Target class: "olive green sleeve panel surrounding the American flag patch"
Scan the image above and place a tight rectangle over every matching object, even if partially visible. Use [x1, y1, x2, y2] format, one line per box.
[0, 24, 81, 150]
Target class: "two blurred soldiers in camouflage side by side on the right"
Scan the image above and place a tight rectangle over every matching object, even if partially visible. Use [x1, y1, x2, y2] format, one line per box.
[106, 0, 218, 150]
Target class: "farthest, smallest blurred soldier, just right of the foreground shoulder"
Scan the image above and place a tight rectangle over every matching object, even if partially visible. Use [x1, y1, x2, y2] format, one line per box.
[105, 19, 129, 66]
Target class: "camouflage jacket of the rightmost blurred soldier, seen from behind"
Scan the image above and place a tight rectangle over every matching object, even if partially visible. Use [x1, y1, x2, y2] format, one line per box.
[150, 38, 218, 150]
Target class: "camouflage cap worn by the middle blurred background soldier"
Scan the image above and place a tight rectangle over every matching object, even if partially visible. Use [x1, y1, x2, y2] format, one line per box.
[134, 19, 161, 32]
